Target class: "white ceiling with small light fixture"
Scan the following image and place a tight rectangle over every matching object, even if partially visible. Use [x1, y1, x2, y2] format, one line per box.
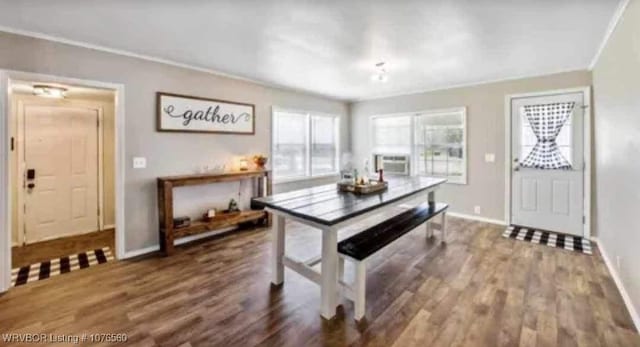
[0, 0, 620, 100]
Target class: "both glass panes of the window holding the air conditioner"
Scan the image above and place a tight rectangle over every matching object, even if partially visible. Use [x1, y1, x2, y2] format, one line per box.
[371, 107, 467, 184]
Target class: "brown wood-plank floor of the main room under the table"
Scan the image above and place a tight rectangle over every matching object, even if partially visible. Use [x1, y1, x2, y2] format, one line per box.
[0, 213, 640, 347]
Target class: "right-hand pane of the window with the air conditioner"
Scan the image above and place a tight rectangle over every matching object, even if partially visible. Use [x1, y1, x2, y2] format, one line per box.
[415, 109, 467, 184]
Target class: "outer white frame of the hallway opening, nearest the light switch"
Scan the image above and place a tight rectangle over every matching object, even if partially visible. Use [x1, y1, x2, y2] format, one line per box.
[0, 70, 126, 292]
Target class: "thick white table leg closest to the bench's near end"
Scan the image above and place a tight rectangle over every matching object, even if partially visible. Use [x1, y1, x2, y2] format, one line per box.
[320, 228, 338, 319]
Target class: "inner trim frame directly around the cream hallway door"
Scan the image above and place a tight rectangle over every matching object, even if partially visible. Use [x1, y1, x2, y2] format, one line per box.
[10, 99, 104, 245]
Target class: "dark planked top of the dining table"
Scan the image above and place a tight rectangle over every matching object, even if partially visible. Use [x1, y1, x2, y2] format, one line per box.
[252, 177, 447, 226]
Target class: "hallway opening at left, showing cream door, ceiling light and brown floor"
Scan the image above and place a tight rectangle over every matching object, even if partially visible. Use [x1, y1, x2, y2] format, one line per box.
[10, 80, 115, 277]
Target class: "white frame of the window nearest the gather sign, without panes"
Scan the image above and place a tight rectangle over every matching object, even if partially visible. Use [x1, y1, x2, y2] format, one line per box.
[270, 106, 341, 183]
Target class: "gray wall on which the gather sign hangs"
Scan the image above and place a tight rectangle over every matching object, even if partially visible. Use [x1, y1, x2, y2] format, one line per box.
[0, 32, 349, 251]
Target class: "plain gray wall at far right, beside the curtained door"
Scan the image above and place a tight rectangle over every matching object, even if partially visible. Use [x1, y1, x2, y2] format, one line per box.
[593, 0, 640, 323]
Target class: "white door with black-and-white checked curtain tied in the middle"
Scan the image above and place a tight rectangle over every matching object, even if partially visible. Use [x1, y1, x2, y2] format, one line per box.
[511, 92, 585, 236]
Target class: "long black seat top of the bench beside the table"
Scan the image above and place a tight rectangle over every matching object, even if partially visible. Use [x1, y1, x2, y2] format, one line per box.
[338, 202, 449, 260]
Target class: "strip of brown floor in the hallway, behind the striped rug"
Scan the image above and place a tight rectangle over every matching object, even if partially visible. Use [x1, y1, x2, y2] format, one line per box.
[11, 229, 115, 269]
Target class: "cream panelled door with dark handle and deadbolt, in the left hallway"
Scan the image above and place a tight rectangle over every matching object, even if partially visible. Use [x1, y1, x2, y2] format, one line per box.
[24, 105, 98, 243]
